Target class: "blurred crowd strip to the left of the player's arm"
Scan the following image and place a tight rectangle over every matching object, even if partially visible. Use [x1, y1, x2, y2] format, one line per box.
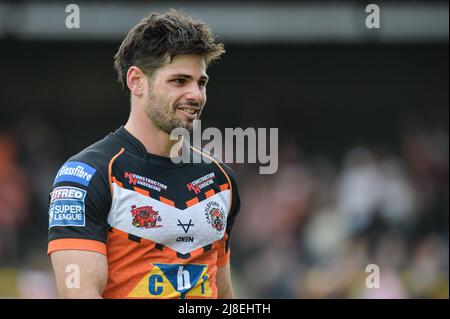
[0, 116, 64, 298]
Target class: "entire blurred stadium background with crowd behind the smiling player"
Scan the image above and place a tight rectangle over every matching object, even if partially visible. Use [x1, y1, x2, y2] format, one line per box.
[0, 0, 449, 298]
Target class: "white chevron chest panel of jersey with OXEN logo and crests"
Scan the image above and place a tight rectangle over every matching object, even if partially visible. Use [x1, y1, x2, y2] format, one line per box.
[108, 184, 229, 254]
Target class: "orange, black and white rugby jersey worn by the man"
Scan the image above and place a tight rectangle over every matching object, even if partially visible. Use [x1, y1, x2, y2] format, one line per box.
[48, 127, 240, 298]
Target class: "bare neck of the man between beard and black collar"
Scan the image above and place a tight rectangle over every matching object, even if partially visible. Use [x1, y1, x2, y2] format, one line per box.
[125, 107, 182, 157]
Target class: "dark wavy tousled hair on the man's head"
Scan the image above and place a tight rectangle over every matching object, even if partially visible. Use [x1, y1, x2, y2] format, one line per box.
[114, 9, 225, 91]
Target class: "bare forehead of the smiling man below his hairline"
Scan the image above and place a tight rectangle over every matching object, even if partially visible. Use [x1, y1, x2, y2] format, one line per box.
[158, 54, 206, 77]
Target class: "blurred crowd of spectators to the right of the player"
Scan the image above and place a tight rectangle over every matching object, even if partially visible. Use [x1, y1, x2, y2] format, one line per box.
[231, 127, 449, 298]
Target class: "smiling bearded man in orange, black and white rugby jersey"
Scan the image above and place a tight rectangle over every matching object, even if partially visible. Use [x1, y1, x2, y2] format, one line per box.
[48, 10, 240, 298]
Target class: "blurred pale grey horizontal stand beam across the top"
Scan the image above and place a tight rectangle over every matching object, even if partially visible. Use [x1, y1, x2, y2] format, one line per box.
[0, 1, 448, 44]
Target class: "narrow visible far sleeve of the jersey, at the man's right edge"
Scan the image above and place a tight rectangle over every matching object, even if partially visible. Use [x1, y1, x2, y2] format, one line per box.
[217, 165, 241, 267]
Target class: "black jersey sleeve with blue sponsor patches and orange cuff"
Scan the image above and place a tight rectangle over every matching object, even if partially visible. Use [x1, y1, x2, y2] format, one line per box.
[47, 156, 111, 255]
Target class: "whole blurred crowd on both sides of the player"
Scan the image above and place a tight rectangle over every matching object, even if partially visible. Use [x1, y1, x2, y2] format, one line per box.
[0, 118, 449, 298]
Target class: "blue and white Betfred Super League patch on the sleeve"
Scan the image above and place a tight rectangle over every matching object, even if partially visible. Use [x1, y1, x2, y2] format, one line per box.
[48, 186, 86, 228]
